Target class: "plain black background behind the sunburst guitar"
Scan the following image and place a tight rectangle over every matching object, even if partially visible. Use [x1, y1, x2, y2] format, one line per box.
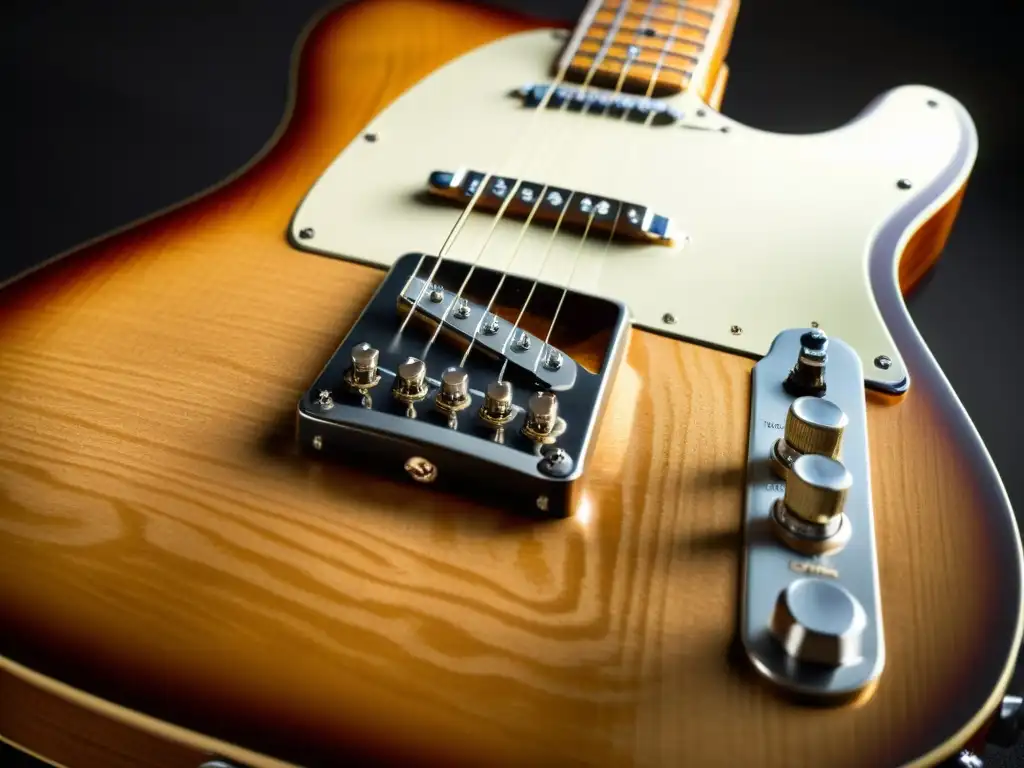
[6, 0, 1024, 760]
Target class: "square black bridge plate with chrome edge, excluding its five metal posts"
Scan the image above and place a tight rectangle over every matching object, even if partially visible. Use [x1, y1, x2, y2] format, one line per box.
[297, 254, 630, 516]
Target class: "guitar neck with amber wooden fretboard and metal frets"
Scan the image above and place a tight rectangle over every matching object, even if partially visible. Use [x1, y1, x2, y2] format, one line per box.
[557, 0, 739, 99]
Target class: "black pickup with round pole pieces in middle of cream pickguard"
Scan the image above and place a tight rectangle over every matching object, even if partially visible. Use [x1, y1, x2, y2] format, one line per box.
[427, 170, 672, 246]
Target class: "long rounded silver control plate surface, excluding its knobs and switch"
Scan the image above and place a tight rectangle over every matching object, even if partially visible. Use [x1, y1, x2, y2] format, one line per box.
[739, 329, 885, 703]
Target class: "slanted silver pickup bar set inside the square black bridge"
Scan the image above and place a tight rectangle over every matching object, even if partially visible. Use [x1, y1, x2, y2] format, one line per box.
[398, 278, 577, 392]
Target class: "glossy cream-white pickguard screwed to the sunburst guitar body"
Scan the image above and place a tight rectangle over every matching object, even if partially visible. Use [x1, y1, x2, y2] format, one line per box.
[291, 31, 975, 389]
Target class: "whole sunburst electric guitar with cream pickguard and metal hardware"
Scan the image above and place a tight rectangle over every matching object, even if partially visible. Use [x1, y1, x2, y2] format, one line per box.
[0, 0, 1022, 768]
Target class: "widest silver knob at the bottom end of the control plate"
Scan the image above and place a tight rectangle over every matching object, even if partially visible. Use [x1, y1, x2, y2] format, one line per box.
[768, 579, 867, 667]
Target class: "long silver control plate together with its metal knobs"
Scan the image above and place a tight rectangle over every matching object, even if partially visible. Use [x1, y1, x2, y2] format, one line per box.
[739, 329, 885, 703]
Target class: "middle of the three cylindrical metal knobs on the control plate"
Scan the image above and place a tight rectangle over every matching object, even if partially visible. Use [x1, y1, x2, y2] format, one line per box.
[772, 454, 853, 554]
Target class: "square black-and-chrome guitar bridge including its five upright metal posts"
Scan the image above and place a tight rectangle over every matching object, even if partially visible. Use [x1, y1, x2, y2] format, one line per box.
[297, 253, 630, 517]
